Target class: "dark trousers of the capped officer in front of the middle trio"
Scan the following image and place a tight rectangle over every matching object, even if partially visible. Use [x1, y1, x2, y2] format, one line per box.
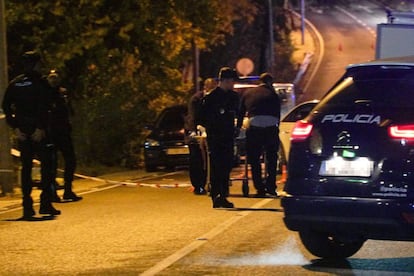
[207, 136, 234, 200]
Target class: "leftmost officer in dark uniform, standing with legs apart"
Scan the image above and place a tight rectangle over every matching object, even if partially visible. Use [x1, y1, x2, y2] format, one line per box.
[2, 51, 60, 219]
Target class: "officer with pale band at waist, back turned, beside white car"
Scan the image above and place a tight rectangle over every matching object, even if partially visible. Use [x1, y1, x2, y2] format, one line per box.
[237, 73, 280, 197]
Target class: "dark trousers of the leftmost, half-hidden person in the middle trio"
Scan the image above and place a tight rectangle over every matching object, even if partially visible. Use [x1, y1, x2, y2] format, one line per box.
[188, 141, 207, 189]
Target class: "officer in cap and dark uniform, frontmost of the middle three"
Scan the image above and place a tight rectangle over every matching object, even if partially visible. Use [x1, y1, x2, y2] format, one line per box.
[201, 67, 239, 208]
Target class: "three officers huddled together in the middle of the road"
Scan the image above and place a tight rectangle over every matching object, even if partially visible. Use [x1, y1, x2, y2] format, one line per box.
[187, 67, 281, 208]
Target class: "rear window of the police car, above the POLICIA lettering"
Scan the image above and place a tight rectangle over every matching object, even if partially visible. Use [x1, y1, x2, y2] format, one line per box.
[322, 66, 414, 107]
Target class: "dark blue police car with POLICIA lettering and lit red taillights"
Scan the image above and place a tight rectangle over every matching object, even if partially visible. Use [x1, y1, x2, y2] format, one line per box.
[282, 56, 414, 259]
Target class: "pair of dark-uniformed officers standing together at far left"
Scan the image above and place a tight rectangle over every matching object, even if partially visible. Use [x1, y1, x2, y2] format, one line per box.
[2, 51, 82, 220]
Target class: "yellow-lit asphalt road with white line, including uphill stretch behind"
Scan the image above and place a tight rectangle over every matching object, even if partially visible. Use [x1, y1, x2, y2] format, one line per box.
[0, 1, 414, 275]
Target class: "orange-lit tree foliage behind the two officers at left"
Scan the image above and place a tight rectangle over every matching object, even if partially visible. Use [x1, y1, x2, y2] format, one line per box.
[6, 0, 292, 169]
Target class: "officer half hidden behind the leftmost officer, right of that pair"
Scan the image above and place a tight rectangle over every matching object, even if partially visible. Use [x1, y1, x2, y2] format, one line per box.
[47, 70, 82, 202]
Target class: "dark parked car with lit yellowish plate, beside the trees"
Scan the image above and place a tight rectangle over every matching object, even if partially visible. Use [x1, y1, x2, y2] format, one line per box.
[144, 105, 189, 171]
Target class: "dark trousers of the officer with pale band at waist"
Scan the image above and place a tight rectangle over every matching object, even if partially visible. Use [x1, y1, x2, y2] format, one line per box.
[246, 126, 280, 193]
